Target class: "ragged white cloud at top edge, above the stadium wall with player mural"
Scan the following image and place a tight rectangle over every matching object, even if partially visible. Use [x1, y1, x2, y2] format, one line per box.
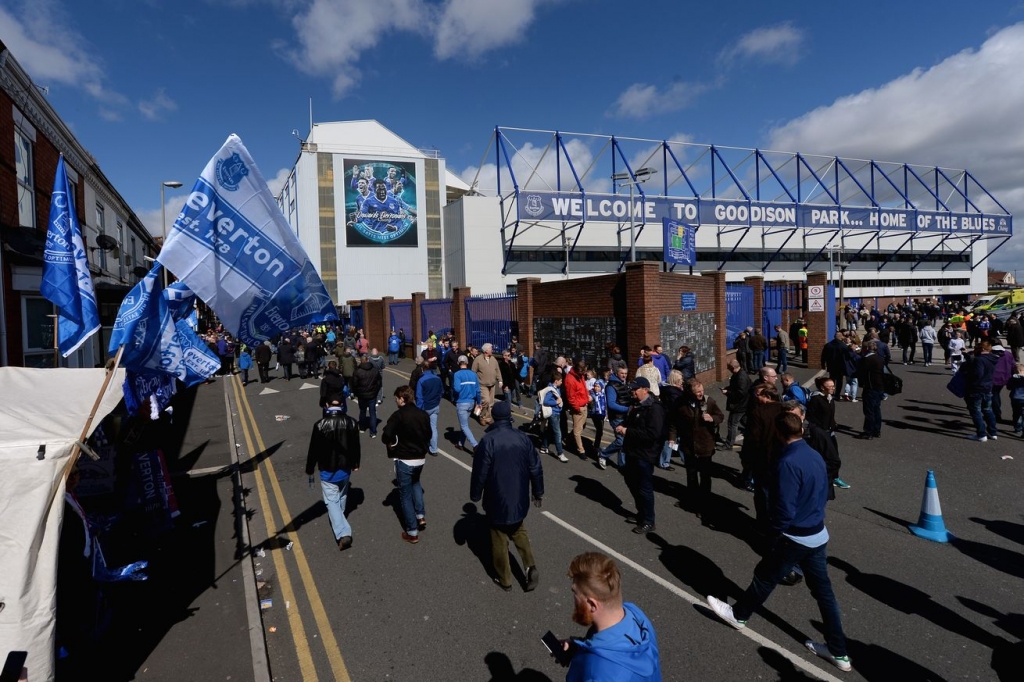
[279, 0, 430, 97]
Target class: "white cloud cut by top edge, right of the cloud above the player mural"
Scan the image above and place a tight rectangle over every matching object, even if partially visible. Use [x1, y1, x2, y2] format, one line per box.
[434, 0, 544, 59]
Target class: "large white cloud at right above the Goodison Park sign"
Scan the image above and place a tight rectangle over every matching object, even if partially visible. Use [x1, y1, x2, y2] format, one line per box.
[768, 24, 1024, 270]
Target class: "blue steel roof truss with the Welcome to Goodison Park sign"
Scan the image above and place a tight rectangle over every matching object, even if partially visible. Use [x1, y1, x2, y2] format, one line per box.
[485, 126, 1013, 274]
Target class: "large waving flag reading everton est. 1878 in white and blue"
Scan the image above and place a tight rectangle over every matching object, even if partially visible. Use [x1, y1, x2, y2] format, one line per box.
[157, 135, 338, 347]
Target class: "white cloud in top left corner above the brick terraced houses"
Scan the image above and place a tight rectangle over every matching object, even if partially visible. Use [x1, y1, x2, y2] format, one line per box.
[0, 0, 128, 106]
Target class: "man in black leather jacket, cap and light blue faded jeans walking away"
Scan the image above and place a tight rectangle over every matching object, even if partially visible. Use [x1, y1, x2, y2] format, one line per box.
[306, 400, 360, 551]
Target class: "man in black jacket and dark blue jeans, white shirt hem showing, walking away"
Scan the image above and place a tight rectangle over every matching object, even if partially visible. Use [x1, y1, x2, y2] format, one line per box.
[383, 384, 430, 545]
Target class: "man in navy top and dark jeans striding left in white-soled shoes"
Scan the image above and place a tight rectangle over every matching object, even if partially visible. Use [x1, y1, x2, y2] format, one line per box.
[708, 412, 852, 672]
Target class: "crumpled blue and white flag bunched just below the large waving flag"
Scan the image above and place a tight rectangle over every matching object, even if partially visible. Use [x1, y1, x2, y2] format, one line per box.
[110, 264, 220, 386]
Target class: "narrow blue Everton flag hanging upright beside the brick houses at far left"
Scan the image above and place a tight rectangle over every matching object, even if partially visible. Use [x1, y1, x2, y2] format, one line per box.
[39, 155, 99, 357]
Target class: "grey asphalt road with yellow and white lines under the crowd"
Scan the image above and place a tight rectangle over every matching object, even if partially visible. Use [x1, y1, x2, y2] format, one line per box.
[220, 360, 1024, 681]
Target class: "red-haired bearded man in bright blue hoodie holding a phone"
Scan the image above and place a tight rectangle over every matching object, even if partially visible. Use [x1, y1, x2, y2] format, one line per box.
[556, 552, 662, 682]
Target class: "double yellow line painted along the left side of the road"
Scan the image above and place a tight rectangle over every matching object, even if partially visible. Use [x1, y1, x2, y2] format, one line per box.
[231, 375, 351, 682]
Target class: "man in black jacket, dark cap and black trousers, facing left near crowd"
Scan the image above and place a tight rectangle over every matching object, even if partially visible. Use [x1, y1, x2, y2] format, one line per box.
[615, 377, 666, 535]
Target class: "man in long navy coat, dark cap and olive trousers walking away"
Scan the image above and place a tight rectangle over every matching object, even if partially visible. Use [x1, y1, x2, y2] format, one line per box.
[469, 400, 544, 592]
